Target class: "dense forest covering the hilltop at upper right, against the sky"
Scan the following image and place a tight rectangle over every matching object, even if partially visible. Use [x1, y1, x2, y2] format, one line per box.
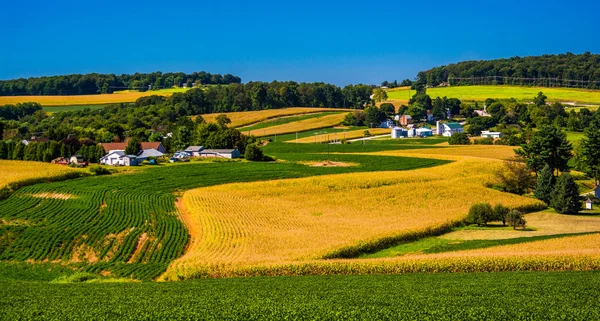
[416, 52, 600, 89]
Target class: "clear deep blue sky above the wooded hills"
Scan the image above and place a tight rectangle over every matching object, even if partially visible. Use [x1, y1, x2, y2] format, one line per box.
[0, 0, 600, 85]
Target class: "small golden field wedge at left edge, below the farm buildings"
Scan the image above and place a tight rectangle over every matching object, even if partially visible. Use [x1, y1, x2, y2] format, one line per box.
[0, 160, 81, 189]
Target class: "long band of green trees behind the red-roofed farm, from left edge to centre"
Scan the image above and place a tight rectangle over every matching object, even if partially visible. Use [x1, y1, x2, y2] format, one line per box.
[0, 82, 373, 146]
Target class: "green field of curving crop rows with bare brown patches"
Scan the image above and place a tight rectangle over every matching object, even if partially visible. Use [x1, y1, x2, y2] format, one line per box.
[0, 176, 187, 278]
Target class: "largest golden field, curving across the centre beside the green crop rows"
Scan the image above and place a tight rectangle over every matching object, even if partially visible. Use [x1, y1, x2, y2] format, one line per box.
[164, 158, 539, 279]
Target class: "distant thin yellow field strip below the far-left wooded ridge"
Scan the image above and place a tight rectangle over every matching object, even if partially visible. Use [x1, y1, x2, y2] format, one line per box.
[0, 90, 183, 106]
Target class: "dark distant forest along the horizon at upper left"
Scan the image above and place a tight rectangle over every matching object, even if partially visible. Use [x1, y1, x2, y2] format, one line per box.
[0, 71, 242, 96]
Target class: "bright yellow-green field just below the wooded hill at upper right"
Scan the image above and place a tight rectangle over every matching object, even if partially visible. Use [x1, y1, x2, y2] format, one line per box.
[387, 86, 600, 104]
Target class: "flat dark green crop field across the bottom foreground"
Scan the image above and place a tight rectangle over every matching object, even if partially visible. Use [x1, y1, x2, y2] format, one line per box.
[0, 272, 600, 320]
